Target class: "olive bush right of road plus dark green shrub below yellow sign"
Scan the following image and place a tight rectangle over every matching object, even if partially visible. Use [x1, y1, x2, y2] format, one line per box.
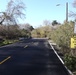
[50, 21, 76, 71]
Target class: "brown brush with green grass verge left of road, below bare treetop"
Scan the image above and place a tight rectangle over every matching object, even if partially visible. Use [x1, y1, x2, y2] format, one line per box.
[0, 24, 34, 46]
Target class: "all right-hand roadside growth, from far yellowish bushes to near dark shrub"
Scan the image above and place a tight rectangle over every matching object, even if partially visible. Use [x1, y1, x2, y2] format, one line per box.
[31, 21, 76, 72]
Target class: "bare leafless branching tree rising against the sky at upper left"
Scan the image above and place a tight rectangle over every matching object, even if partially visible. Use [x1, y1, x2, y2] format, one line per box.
[0, 0, 25, 24]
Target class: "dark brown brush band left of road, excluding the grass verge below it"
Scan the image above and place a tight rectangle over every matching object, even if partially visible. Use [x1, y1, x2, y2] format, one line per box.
[0, 25, 31, 39]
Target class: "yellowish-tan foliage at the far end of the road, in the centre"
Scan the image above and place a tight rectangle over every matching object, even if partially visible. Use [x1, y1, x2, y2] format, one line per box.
[31, 25, 51, 38]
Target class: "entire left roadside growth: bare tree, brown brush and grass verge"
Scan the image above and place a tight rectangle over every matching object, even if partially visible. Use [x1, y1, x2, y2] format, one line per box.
[0, 0, 34, 46]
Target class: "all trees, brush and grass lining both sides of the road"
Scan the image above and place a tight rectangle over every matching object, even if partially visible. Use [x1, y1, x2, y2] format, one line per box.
[0, 0, 76, 72]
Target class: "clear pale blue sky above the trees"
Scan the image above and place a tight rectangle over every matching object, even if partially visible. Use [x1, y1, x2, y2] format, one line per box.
[0, 0, 76, 27]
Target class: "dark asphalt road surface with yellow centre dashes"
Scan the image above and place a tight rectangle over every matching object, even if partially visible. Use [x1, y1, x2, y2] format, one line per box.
[0, 39, 69, 75]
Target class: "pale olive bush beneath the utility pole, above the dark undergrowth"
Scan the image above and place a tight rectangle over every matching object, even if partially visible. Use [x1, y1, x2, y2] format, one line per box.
[51, 22, 74, 51]
